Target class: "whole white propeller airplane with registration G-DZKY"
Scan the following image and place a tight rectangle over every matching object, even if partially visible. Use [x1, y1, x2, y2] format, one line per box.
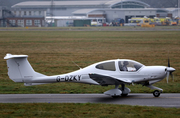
[4, 54, 175, 97]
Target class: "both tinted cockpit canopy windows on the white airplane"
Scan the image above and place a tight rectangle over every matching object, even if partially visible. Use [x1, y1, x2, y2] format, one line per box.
[96, 60, 143, 72]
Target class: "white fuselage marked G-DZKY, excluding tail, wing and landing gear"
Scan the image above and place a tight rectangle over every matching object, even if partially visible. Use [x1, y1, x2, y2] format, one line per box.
[29, 59, 167, 85]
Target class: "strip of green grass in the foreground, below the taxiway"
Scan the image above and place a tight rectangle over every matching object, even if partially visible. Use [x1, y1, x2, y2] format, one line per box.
[0, 103, 180, 118]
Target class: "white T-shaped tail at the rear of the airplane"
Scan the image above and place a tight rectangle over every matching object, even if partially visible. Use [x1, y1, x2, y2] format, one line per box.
[4, 54, 47, 86]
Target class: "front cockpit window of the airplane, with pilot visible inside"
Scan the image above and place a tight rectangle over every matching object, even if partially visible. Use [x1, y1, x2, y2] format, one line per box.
[118, 61, 143, 72]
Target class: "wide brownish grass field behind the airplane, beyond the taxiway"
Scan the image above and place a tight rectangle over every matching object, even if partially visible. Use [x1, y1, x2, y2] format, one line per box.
[0, 31, 180, 93]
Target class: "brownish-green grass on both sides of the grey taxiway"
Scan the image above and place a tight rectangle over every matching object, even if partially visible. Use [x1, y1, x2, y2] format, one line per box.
[0, 31, 180, 118]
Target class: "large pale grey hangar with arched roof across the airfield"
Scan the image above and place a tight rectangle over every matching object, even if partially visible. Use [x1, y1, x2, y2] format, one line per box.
[12, 0, 156, 22]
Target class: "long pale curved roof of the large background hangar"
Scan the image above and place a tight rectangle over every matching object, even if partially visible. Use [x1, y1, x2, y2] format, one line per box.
[12, 0, 150, 8]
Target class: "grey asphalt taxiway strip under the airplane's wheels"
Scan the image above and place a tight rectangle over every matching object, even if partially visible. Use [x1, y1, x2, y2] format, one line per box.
[0, 93, 180, 108]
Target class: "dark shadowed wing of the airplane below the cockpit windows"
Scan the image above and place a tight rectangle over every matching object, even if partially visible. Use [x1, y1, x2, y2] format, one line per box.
[89, 73, 132, 86]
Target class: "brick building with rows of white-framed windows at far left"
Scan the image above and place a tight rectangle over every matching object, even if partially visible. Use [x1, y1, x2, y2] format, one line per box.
[0, 7, 46, 27]
